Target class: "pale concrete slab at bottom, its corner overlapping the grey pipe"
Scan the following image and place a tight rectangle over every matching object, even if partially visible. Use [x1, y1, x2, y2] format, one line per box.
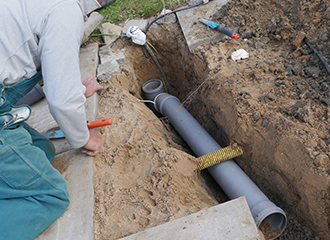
[121, 197, 262, 240]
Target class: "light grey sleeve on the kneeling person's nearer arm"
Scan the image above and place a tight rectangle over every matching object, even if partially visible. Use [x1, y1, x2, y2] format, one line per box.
[39, 1, 89, 148]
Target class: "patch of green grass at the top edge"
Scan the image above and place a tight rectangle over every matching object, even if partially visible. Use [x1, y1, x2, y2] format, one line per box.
[98, 0, 189, 24]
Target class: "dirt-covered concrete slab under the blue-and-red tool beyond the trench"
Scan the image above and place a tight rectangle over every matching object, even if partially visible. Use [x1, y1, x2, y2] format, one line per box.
[177, 0, 233, 52]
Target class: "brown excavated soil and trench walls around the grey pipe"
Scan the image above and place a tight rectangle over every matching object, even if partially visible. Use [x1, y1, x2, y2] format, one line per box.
[94, 0, 330, 239]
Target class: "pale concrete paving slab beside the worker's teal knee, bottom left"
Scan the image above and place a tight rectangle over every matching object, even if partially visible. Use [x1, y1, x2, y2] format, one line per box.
[35, 149, 94, 240]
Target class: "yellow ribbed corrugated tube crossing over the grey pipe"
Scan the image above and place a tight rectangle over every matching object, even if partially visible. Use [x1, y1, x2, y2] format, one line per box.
[197, 146, 243, 170]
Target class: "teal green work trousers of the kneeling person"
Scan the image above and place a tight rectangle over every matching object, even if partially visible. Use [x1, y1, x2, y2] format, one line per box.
[0, 73, 69, 240]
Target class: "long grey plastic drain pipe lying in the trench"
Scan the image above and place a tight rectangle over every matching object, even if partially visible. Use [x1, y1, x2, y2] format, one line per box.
[154, 93, 287, 237]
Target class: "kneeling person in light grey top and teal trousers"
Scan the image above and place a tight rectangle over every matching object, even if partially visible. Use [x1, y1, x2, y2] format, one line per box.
[0, 0, 113, 240]
